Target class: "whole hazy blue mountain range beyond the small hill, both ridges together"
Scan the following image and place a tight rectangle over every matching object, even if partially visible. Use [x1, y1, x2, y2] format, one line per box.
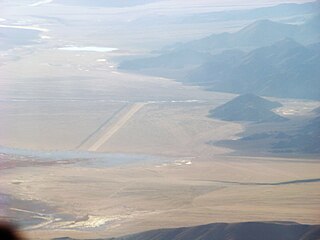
[119, 15, 320, 99]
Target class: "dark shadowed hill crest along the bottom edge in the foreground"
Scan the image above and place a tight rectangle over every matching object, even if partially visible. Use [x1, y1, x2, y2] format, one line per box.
[55, 222, 320, 240]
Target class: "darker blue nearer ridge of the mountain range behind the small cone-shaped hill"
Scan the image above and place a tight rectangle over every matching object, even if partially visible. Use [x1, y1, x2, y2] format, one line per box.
[188, 39, 320, 99]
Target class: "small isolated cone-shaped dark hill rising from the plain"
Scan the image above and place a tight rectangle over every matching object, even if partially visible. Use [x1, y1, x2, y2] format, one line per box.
[209, 94, 286, 122]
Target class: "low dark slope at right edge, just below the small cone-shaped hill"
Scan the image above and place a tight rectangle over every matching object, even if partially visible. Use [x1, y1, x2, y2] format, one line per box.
[215, 108, 320, 156]
